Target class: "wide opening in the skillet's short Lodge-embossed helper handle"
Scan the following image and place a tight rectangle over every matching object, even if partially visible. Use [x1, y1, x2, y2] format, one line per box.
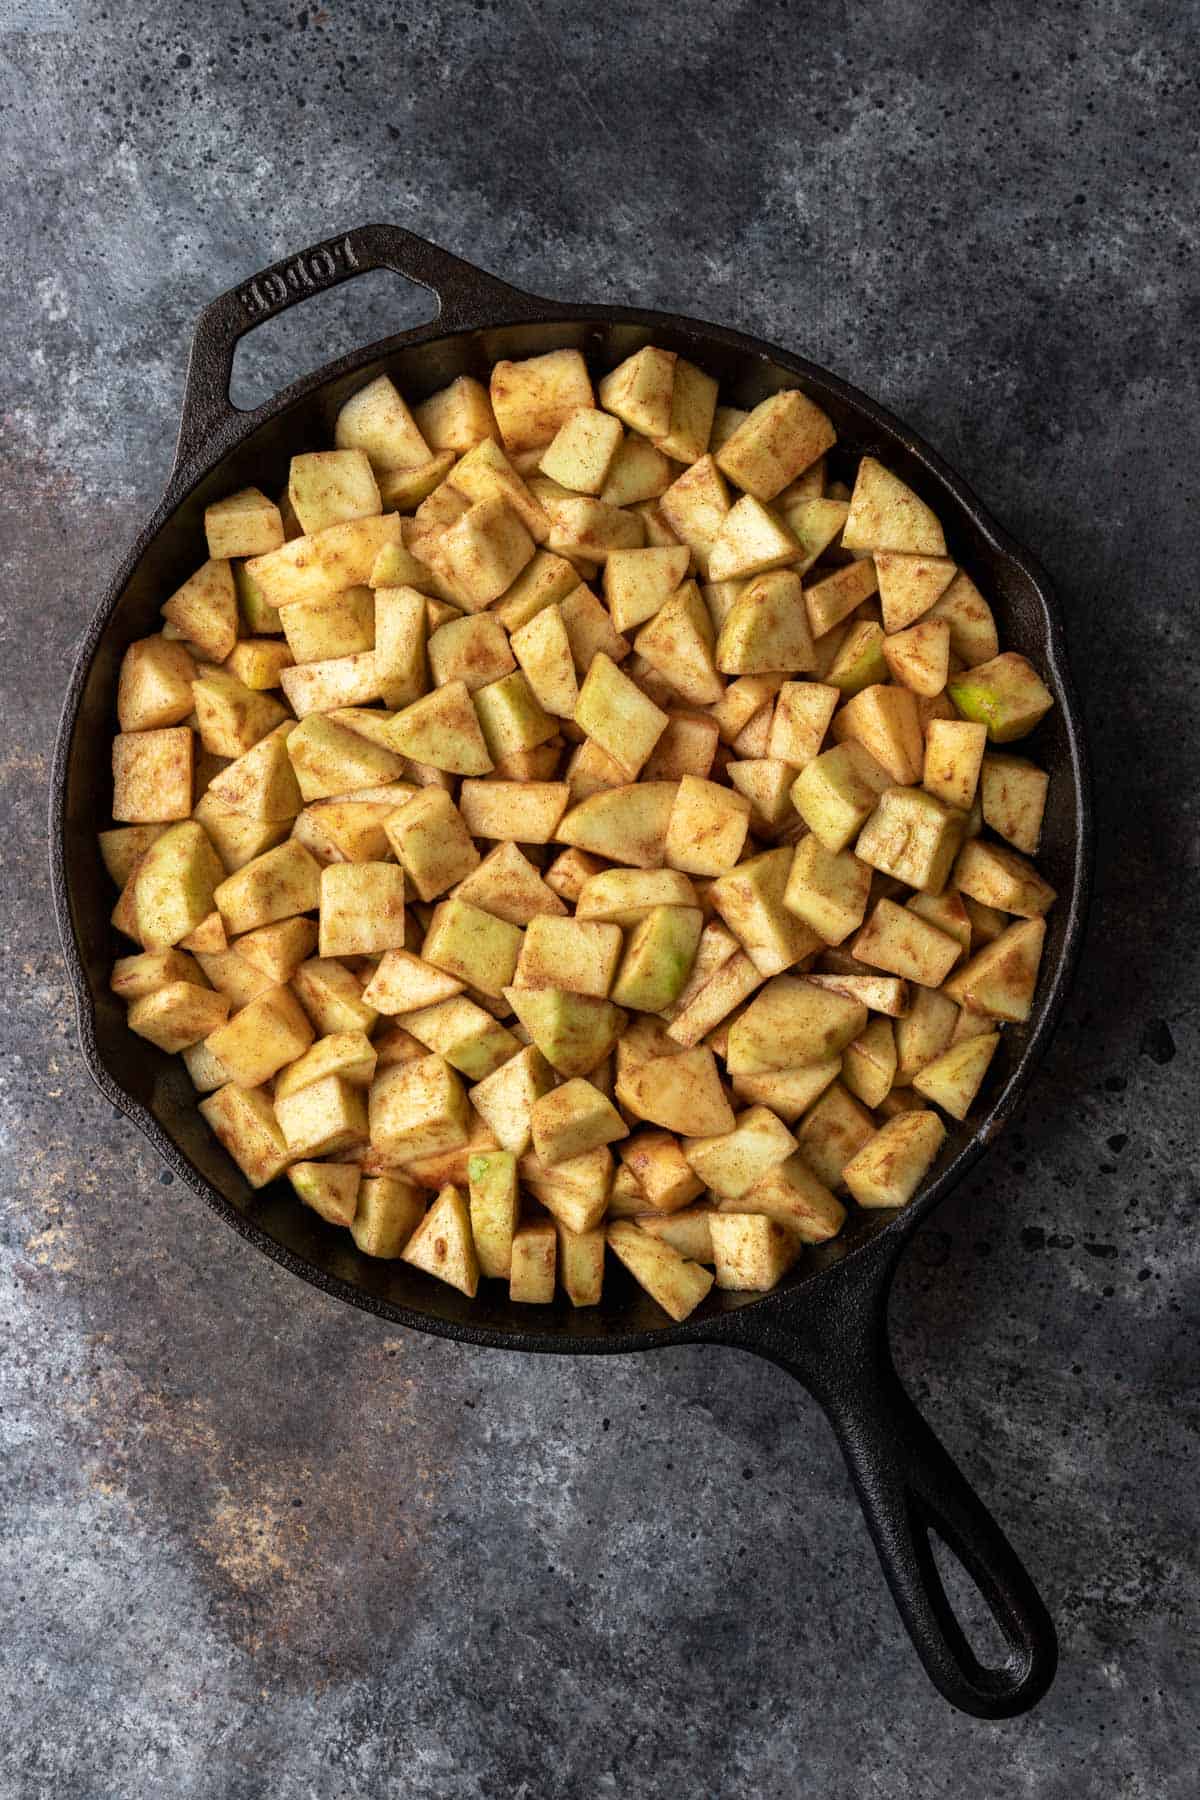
[228, 268, 437, 412]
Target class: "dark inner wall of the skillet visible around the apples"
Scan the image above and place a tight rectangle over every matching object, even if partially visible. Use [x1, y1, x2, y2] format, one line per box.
[59, 313, 1087, 1350]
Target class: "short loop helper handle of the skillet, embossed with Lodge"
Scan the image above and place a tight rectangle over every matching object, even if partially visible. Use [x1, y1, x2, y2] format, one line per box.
[171, 225, 547, 482]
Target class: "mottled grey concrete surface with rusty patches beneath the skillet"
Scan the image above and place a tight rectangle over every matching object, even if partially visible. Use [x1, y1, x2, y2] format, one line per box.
[0, 0, 1200, 1800]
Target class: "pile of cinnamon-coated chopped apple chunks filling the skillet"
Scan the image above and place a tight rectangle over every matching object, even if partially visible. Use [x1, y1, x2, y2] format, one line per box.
[101, 346, 1054, 1319]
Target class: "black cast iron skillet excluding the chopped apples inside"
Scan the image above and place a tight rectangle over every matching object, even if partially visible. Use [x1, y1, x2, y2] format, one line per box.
[50, 225, 1092, 1719]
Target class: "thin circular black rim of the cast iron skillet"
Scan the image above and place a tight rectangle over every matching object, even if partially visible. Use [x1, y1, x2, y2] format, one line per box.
[49, 291, 1094, 1355]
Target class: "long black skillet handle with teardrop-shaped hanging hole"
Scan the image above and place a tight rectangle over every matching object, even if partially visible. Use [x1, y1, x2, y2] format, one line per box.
[725, 1240, 1058, 1719]
